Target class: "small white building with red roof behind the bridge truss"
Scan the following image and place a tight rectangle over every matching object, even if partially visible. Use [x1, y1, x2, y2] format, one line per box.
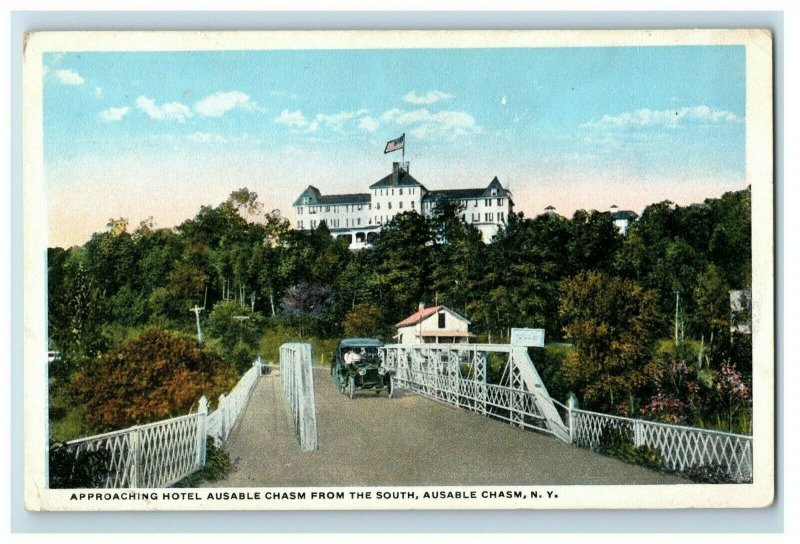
[395, 304, 471, 344]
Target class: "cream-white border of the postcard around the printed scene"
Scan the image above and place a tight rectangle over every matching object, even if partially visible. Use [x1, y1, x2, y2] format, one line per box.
[23, 29, 775, 511]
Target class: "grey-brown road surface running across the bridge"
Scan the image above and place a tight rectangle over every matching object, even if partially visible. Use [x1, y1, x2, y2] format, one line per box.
[207, 369, 687, 487]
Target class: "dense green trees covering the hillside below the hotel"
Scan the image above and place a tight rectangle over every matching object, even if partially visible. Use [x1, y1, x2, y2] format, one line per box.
[48, 189, 751, 434]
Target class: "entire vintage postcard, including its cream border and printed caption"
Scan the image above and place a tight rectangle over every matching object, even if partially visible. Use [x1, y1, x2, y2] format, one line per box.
[23, 29, 775, 511]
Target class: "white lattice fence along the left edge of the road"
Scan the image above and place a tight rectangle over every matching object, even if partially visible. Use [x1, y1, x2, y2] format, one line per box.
[67, 358, 262, 488]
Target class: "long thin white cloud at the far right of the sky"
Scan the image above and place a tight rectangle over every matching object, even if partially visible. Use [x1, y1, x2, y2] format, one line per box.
[582, 105, 742, 129]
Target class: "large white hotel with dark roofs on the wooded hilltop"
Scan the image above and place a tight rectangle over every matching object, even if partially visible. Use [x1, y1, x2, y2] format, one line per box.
[293, 162, 514, 249]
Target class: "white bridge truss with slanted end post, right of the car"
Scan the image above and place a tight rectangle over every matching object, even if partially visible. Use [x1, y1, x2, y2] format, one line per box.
[382, 344, 569, 441]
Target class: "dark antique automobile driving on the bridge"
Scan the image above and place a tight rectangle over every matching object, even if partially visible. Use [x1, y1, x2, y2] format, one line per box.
[331, 338, 394, 399]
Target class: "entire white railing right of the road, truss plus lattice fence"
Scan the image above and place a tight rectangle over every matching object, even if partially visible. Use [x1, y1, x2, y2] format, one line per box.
[383, 344, 753, 482]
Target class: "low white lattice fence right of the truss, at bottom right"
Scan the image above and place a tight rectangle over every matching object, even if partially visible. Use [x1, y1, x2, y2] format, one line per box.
[564, 407, 753, 482]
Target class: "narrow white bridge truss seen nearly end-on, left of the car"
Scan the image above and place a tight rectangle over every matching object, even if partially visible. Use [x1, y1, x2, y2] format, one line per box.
[280, 343, 318, 451]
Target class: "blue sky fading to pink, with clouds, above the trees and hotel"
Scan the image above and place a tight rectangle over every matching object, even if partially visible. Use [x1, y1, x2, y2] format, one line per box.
[44, 46, 746, 245]
